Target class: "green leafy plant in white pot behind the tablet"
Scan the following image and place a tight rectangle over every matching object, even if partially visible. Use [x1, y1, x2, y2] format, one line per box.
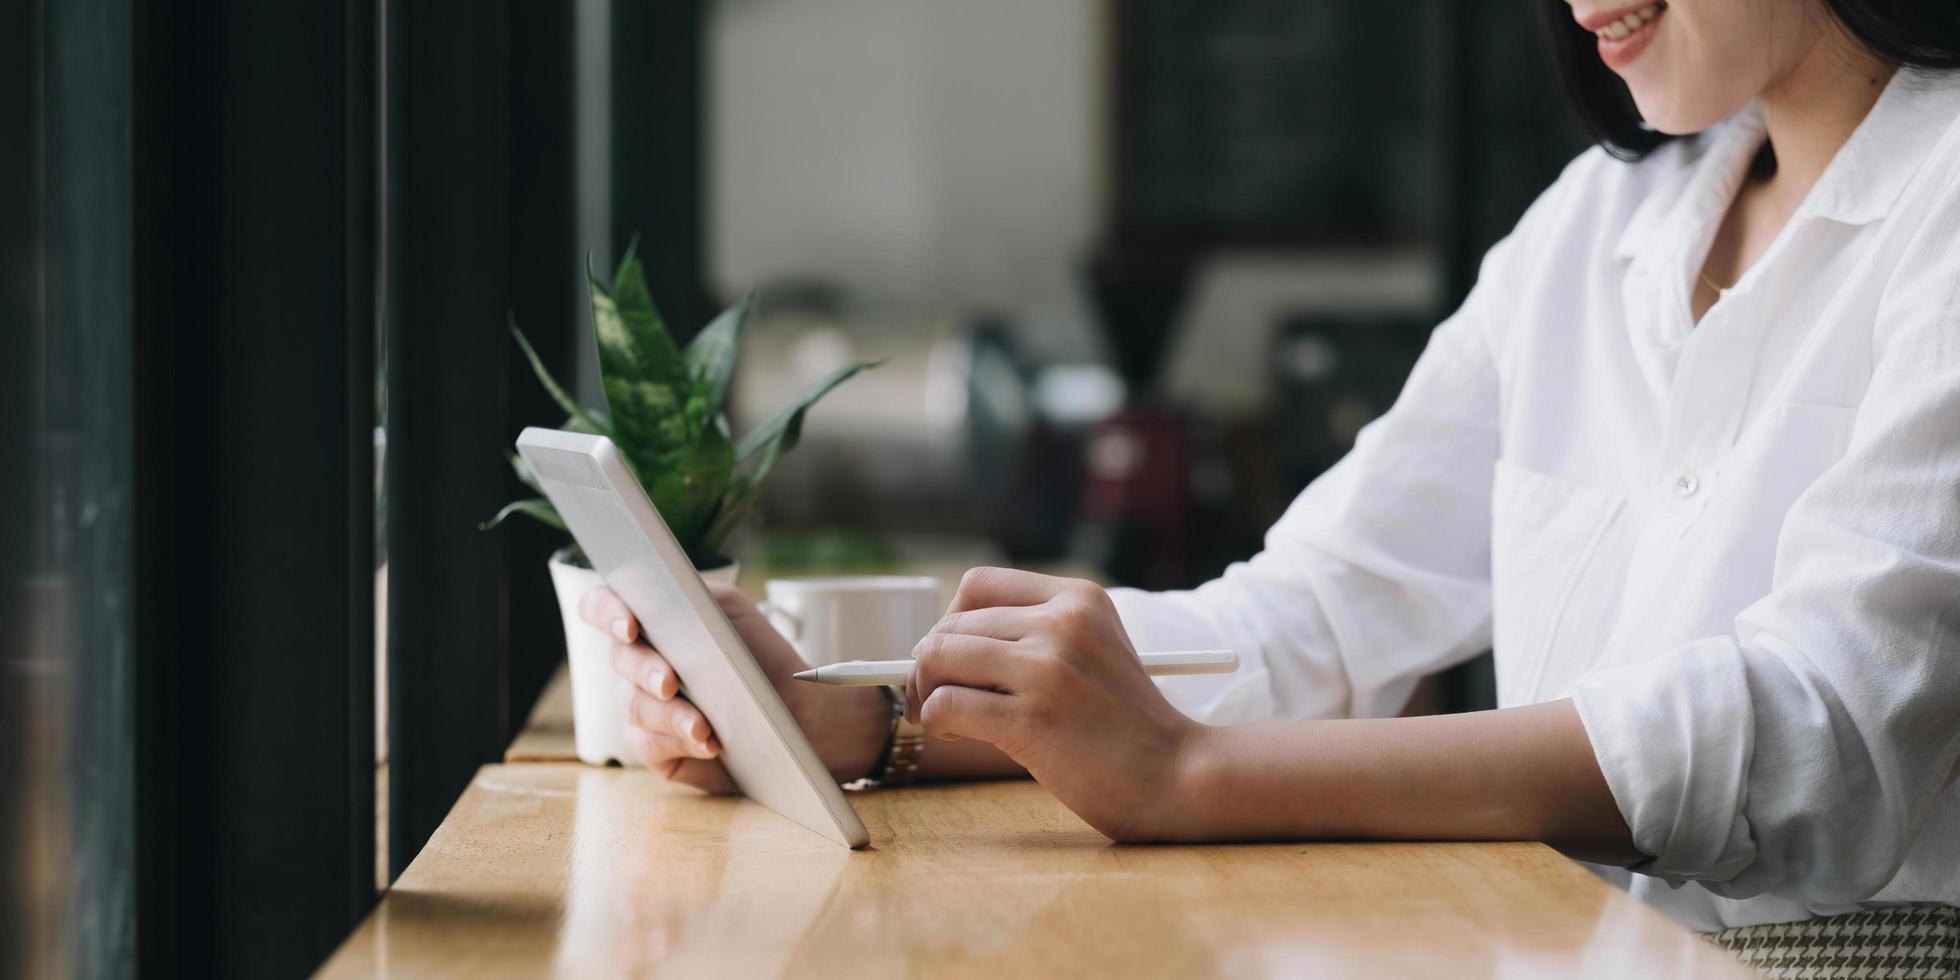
[484, 245, 872, 764]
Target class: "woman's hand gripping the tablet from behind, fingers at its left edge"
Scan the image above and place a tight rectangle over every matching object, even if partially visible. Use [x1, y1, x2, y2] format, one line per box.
[578, 584, 892, 794]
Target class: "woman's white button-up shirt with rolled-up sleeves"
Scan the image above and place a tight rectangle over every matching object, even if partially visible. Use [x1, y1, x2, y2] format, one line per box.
[1115, 74, 1960, 929]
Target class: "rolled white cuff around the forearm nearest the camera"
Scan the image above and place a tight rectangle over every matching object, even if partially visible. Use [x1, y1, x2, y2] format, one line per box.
[1572, 637, 1756, 884]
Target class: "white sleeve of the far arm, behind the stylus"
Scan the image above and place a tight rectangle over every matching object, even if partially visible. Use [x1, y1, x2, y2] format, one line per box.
[1111, 235, 1515, 723]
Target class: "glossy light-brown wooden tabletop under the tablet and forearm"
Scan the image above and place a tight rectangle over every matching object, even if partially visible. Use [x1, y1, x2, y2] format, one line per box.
[323, 764, 1750, 978]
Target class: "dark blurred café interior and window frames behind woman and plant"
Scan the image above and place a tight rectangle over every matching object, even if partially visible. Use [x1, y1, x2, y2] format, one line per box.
[0, 0, 1584, 976]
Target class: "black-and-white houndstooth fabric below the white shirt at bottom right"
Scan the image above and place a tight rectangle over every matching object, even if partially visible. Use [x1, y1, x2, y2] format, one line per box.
[1707, 906, 1960, 980]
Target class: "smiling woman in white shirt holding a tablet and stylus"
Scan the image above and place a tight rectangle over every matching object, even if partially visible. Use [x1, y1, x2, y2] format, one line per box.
[586, 0, 1960, 952]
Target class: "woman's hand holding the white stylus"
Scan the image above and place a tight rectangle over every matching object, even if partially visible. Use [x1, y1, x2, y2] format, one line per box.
[906, 568, 1205, 841]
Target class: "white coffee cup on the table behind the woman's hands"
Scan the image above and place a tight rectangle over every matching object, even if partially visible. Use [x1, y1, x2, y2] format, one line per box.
[762, 574, 945, 666]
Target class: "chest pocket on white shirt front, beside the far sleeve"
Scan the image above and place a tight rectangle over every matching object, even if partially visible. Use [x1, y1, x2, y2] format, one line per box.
[1490, 459, 1623, 708]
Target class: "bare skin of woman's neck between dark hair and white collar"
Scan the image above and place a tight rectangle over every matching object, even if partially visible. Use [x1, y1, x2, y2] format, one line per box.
[1760, 22, 1895, 202]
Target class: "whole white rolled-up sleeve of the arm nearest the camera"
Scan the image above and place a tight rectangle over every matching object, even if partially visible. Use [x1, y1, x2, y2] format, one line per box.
[1572, 223, 1960, 904]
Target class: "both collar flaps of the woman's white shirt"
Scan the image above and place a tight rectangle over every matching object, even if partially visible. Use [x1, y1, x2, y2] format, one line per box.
[1615, 71, 1960, 259]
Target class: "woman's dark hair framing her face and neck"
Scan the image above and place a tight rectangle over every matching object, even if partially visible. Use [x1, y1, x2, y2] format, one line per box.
[1537, 0, 1960, 161]
